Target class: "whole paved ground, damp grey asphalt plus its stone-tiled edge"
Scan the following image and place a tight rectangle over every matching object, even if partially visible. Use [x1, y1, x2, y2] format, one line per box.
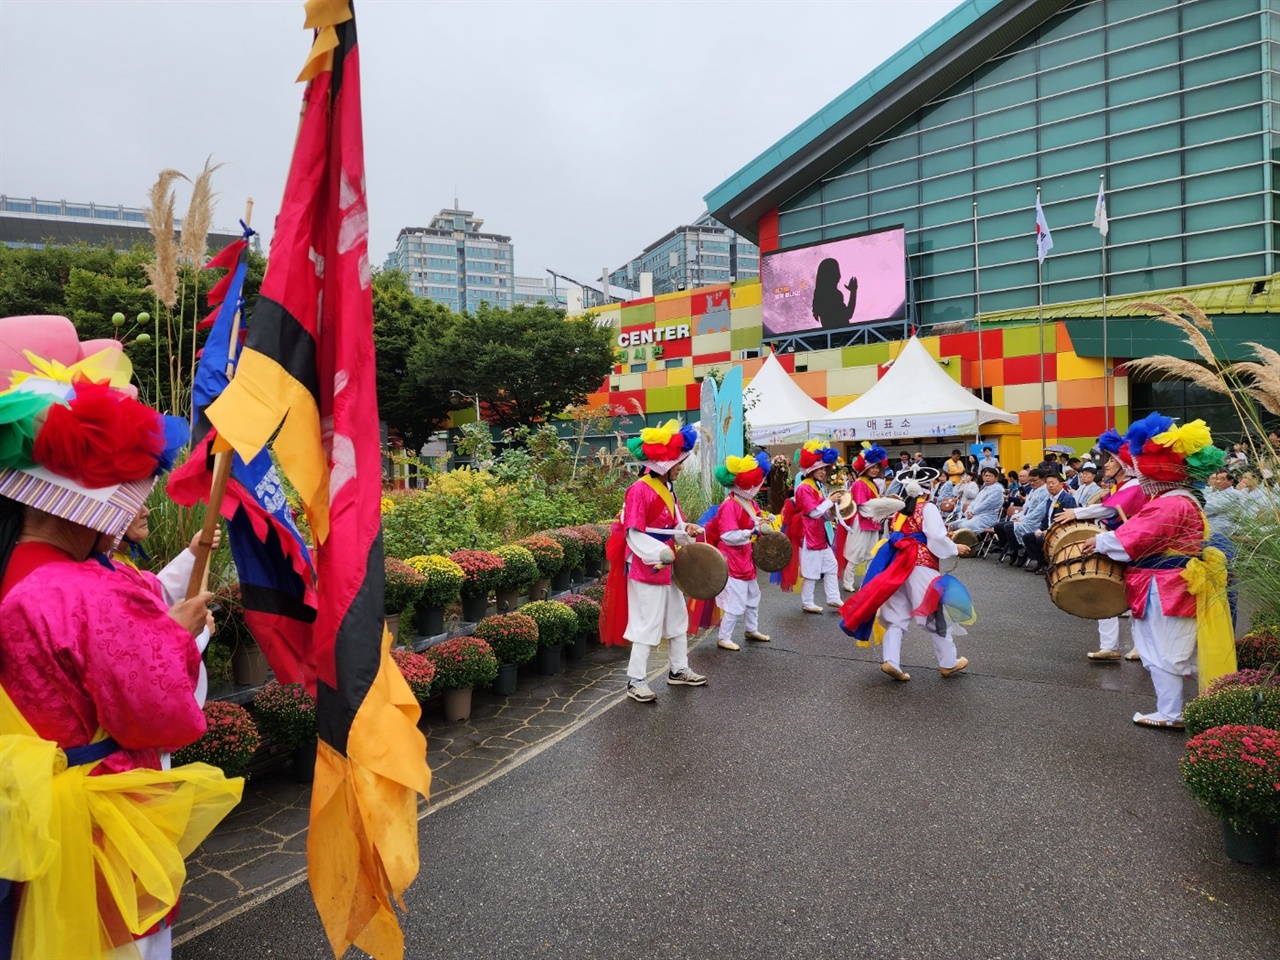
[177, 561, 1280, 960]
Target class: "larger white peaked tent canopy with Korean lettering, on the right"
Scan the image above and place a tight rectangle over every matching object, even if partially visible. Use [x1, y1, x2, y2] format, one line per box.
[819, 337, 1018, 440]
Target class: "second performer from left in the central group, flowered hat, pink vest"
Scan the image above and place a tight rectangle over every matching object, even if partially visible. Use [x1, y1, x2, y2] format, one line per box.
[716, 453, 773, 650]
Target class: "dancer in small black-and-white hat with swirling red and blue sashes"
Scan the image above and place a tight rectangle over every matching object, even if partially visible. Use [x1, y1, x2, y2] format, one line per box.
[840, 467, 973, 681]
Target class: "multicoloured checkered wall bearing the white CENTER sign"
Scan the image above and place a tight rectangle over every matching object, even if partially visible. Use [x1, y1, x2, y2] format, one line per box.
[589, 280, 1129, 462]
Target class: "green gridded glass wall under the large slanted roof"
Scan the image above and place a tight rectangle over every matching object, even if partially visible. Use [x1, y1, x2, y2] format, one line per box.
[776, 0, 1280, 328]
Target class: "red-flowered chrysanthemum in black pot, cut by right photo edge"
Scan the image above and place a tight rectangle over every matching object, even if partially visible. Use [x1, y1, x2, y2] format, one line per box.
[1179, 723, 1280, 867]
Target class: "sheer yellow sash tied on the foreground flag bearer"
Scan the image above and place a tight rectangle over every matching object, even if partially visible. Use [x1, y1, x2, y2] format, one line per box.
[0, 687, 244, 960]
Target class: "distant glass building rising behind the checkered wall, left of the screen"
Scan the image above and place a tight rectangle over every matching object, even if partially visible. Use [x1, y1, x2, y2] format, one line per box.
[609, 212, 760, 294]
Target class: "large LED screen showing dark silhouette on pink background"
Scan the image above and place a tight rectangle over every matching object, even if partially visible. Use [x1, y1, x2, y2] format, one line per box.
[760, 227, 906, 338]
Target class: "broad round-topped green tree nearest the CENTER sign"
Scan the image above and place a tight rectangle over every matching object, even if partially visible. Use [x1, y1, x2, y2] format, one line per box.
[420, 303, 614, 428]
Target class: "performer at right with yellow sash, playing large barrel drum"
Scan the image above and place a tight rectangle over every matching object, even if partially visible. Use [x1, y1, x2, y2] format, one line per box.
[1083, 413, 1235, 730]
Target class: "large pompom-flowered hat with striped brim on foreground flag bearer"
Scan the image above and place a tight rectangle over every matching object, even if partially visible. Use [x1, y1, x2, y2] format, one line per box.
[0, 317, 189, 536]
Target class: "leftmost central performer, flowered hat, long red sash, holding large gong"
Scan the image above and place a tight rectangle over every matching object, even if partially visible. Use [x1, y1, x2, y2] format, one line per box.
[603, 420, 707, 703]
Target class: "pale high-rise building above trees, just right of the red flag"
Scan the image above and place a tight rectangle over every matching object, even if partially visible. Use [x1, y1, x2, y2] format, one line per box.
[384, 210, 516, 312]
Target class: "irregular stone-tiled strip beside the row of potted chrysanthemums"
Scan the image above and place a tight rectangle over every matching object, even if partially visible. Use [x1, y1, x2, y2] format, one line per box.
[174, 644, 640, 945]
